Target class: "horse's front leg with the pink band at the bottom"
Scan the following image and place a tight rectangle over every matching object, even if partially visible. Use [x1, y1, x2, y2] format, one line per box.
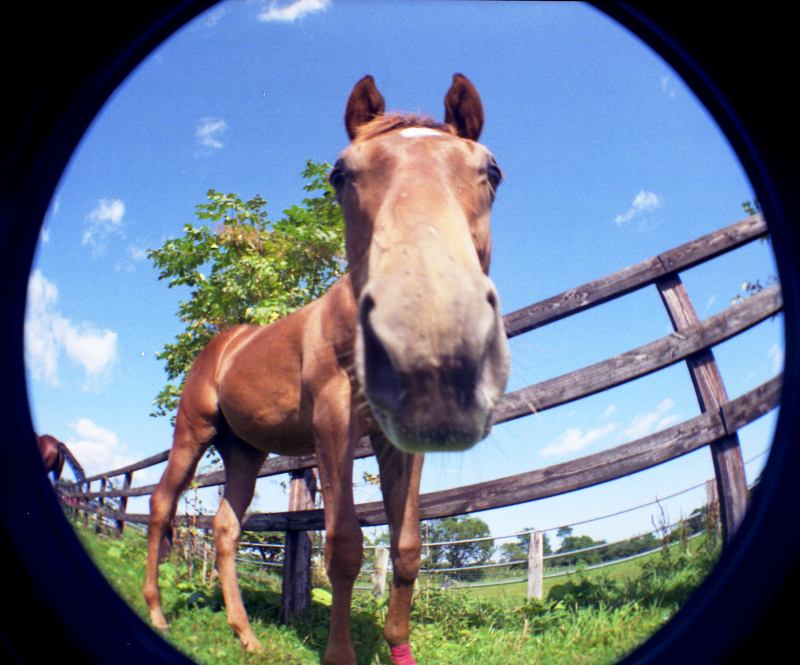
[370, 434, 424, 665]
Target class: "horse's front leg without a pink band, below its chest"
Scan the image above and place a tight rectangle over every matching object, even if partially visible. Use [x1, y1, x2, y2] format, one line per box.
[314, 391, 363, 665]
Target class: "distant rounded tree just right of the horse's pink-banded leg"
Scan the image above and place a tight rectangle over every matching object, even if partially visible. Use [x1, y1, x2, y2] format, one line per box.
[423, 516, 494, 568]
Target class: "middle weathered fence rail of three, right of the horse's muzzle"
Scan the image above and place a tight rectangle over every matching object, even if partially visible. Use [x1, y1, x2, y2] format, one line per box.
[494, 286, 782, 423]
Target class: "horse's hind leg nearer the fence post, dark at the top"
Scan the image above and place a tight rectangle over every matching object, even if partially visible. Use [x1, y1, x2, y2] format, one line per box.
[213, 441, 267, 652]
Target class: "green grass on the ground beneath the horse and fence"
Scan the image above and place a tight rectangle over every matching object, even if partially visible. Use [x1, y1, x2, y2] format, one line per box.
[75, 526, 715, 665]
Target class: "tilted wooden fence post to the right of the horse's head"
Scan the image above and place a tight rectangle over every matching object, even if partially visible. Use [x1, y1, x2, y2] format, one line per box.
[656, 275, 747, 544]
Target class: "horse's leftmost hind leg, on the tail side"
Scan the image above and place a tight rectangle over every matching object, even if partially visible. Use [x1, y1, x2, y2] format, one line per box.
[142, 413, 214, 630]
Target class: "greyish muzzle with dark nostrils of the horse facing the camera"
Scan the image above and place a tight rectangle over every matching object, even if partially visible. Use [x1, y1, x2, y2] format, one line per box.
[356, 278, 509, 453]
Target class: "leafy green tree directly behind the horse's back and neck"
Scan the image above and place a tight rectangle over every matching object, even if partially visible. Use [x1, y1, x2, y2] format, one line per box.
[147, 161, 345, 416]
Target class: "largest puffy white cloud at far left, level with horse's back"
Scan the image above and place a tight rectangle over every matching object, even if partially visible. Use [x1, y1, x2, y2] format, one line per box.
[25, 270, 117, 387]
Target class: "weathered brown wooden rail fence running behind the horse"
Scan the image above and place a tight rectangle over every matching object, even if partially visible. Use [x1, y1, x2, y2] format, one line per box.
[62, 215, 782, 616]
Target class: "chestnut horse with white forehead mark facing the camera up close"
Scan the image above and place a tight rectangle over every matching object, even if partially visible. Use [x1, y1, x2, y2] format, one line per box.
[144, 74, 509, 665]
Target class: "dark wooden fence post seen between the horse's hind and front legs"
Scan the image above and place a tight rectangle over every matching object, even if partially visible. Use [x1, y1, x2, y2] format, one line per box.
[280, 469, 317, 624]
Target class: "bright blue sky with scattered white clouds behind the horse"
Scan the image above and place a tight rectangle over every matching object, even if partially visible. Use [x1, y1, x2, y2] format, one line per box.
[25, 0, 784, 541]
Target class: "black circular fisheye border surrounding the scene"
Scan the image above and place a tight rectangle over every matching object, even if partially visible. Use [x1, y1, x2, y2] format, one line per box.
[0, 0, 800, 665]
